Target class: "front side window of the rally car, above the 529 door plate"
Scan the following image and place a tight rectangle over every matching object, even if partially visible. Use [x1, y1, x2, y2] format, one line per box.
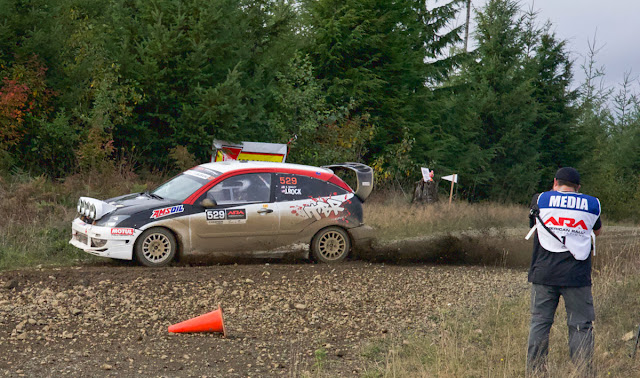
[207, 173, 271, 205]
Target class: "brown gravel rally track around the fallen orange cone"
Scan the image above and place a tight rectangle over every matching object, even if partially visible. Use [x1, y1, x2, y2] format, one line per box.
[0, 260, 527, 377]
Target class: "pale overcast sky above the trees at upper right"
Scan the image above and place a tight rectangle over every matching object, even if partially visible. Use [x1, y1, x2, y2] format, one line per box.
[457, 0, 640, 93]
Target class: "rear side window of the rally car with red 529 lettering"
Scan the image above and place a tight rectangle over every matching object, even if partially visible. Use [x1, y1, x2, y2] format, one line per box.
[275, 173, 347, 202]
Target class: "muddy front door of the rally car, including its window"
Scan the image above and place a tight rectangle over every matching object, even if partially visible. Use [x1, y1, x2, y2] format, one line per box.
[190, 173, 280, 252]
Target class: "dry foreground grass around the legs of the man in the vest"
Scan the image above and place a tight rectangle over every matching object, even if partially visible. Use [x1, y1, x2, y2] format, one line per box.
[364, 231, 640, 377]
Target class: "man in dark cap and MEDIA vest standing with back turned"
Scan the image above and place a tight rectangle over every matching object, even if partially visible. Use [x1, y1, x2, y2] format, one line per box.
[527, 167, 602, 372]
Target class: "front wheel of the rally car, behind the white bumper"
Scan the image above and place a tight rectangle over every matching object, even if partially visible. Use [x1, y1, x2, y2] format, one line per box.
[134, 227, 178, 267]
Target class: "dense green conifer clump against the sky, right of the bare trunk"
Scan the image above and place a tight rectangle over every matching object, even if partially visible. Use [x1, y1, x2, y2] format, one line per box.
[418, 0, 578, 202]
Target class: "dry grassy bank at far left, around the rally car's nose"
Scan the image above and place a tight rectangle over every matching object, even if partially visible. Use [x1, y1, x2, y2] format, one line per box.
[0, 164, 162, 270]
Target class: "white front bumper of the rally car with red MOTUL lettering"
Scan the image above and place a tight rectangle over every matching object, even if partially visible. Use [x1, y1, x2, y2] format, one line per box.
[69, 218, 142, 260]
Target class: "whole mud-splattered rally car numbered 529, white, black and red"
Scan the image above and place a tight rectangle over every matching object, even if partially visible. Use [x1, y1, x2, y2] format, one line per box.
[70, 161, 373, 266]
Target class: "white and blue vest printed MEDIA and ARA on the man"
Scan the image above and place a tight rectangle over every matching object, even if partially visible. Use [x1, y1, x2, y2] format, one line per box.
[536, 191, 600, 260]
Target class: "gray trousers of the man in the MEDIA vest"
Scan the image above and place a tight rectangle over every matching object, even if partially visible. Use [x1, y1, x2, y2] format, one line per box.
[527, 284, 596, 372]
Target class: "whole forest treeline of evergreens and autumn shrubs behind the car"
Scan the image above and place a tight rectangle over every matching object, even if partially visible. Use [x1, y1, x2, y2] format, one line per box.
[0, 0, 640, 218]
